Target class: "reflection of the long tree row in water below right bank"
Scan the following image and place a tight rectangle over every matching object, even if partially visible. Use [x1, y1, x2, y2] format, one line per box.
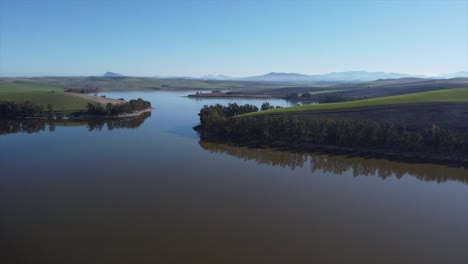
[199, 141, 468, 184]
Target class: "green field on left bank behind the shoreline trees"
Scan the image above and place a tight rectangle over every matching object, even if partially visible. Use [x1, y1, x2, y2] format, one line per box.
[0, 80, 89, 112]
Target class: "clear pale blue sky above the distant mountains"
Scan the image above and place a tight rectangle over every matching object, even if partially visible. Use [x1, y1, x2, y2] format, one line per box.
[0, 0, 468, 77]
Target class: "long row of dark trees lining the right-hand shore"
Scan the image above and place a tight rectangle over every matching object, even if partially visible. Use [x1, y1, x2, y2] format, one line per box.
[197, 105, 468, 158]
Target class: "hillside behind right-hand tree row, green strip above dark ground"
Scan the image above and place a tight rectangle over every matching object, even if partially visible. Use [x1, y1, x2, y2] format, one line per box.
[246, 88, 468, 131]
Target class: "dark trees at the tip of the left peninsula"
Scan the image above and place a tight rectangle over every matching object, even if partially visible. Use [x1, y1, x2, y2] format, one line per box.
[86, 98, 151, 115]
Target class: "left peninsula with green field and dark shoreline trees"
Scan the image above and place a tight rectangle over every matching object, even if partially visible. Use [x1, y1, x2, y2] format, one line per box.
[0, 78, 153, 119]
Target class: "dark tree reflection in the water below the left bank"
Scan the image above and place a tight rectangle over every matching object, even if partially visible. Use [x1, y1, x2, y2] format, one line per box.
[0, 112, 151, 135]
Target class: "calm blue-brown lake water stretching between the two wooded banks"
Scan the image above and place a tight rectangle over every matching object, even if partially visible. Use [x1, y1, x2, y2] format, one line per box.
[0, 92, 468, 264]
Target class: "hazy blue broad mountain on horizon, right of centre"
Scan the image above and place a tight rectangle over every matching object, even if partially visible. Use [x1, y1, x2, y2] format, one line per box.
[244, 71, 427, 82]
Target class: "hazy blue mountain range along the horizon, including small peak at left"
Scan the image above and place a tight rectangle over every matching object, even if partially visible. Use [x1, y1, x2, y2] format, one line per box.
[104, 71, 468, 83]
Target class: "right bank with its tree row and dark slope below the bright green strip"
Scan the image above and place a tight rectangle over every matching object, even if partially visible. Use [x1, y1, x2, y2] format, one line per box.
[194, 99, 468, 167]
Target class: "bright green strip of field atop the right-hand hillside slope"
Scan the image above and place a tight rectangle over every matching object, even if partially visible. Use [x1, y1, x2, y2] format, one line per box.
[254, 88, 468, 115]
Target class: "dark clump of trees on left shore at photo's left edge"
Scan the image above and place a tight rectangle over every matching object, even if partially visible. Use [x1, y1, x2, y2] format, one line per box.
[0, 101, 54, 117]
